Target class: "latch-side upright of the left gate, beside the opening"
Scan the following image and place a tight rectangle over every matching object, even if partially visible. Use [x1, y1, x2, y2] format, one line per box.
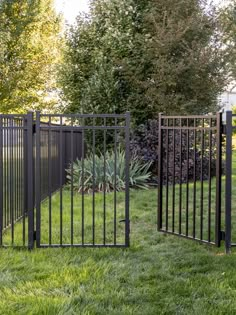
[125, 112, 130, 247]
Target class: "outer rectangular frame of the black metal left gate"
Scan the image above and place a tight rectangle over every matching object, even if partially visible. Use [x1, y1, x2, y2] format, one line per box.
[33, 111, 131, 249]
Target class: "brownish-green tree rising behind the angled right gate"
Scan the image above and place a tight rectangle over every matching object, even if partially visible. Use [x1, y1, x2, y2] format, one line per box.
[145, 0, 228, 114]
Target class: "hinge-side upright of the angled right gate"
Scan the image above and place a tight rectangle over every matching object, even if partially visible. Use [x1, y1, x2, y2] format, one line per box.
[215, 113, 222, 247]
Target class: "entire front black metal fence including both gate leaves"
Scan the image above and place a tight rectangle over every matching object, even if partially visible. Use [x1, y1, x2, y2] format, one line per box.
[0, 112, 236, 252]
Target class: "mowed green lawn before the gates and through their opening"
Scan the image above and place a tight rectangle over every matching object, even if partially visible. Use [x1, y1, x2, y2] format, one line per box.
[0, 159, 236, 315]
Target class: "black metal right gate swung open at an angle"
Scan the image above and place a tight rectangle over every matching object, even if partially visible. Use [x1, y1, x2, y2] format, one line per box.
[158, 113, 225, 246]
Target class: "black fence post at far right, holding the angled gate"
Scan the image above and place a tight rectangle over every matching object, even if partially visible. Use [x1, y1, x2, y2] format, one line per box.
[225, 111, 232, 254]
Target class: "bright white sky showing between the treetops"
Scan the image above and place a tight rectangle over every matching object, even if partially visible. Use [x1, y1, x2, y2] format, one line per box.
[54, 0, 227, 24]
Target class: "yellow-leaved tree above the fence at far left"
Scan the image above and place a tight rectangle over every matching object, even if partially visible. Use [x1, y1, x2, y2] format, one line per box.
[0, 0, 61, 113]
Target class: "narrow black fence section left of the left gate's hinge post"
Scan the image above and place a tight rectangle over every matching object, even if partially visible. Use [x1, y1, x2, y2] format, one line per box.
[0, 115, 28, 246]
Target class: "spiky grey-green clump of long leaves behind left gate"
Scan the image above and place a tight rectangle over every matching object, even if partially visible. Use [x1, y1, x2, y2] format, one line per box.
[67, 150, 151, 193]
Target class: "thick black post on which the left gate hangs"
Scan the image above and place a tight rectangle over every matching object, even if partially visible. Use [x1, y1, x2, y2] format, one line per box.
[24, 112, 34, 249]
